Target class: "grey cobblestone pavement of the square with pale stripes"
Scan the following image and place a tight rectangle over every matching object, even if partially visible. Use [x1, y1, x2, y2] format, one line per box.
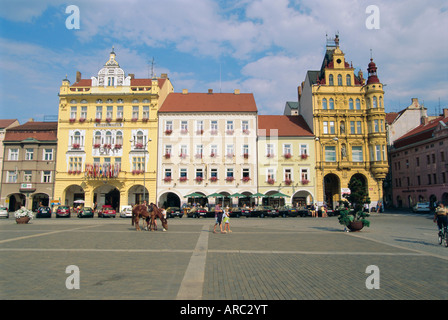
[0, 213, 448, 300]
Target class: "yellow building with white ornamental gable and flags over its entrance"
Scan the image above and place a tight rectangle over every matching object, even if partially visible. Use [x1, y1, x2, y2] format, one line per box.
[54, 50, 173, 211]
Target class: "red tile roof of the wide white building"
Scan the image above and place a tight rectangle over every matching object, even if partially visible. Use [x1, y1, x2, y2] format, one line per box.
[159, 93, 257, 113]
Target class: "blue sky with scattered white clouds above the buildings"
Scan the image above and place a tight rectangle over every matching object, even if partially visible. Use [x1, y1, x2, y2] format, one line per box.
[0, 0, 448, 123]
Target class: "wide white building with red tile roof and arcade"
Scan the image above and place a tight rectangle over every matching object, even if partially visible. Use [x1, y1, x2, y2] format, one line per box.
[157, 90, 257, 206]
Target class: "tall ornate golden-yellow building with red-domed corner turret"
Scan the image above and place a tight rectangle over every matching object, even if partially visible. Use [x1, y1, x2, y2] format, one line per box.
[298, 36, 388, 207]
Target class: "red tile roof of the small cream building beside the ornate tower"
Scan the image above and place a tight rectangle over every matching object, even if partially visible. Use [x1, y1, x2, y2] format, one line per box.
[258, 115, 314, 137]
